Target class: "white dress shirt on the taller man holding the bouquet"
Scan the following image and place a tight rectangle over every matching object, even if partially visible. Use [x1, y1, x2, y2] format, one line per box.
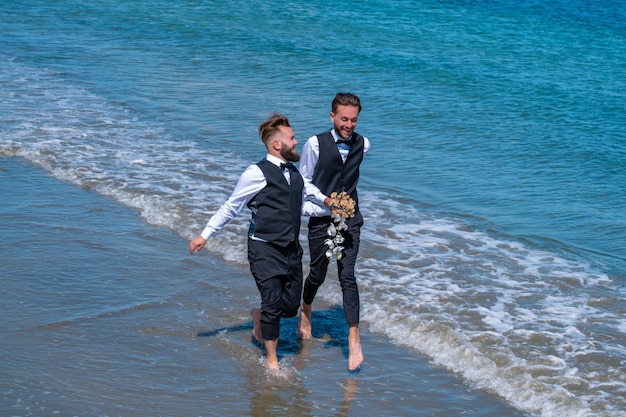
[299, 129, 370, 217]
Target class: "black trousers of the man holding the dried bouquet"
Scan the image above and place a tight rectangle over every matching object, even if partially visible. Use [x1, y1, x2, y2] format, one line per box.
[302, 212, 363, 324]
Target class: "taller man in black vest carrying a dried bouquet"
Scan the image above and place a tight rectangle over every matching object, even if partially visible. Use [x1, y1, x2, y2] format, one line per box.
[298, 93, 370, 371]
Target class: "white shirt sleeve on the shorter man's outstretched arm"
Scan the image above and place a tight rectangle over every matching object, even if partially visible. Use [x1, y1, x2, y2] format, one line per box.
[200, 165, 267, 240]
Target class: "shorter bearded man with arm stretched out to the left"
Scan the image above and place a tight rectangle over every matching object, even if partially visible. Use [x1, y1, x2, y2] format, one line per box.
[189, 114, 304, 370]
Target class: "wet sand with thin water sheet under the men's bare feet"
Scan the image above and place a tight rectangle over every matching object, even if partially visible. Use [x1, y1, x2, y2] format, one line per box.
[0, 158, 527, 417]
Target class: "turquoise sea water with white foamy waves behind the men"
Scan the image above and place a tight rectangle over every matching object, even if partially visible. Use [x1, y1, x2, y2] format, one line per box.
[0, 0, 626, 416]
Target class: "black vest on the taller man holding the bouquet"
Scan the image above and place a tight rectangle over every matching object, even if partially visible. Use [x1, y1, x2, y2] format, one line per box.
[313, 131, 365, 212]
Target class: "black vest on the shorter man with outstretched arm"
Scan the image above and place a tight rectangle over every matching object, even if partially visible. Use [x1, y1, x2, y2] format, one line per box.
[248, 159, 304, 246]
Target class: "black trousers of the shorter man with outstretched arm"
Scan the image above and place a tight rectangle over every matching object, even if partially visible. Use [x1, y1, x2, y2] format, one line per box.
[248, 239, 302, 340]
